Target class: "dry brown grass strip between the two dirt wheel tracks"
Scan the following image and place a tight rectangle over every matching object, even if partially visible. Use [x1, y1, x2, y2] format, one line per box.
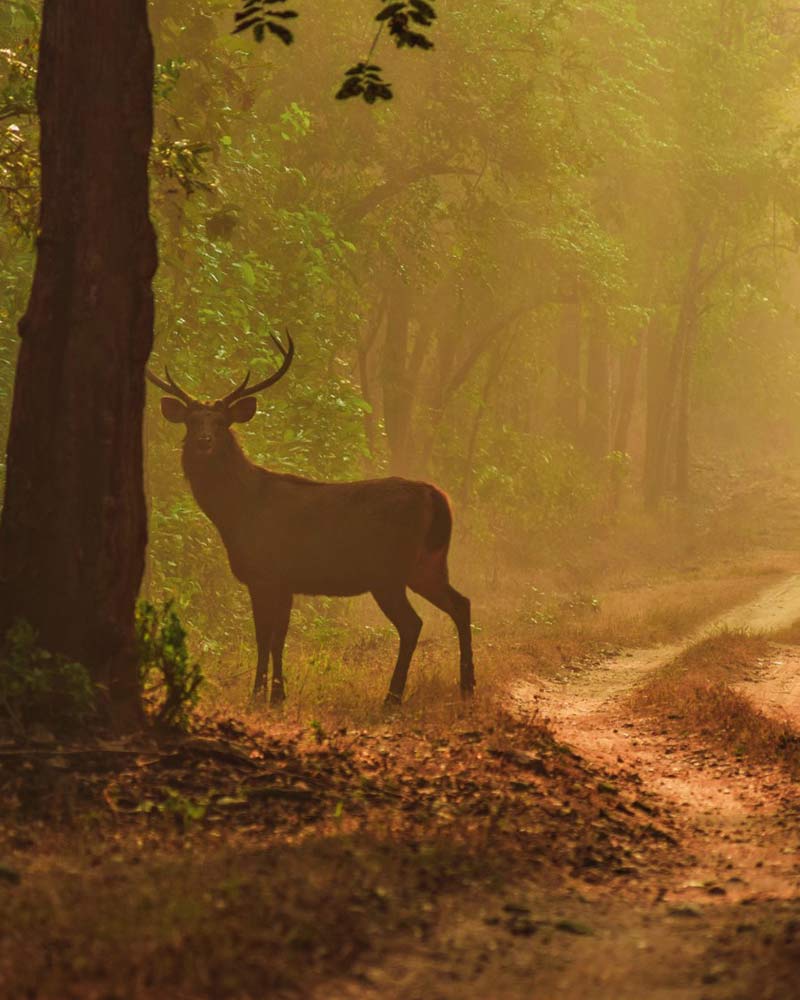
[631, 631, 800, 775]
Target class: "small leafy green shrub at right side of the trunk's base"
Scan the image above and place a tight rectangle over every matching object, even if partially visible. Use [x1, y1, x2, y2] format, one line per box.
[136, 601, 203, 729]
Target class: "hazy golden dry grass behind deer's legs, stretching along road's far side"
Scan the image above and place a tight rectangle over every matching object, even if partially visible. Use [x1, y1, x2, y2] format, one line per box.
[188, 460, 800, 725]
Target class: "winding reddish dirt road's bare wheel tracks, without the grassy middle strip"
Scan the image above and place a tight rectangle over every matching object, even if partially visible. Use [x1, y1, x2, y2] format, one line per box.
[331, 576, 800, 1000]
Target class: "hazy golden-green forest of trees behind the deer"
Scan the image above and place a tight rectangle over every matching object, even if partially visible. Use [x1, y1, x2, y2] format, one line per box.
[0, 0, 800, 688]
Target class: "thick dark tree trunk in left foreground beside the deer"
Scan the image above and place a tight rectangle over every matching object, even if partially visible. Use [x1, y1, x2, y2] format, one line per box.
[0, 0, 156, 722]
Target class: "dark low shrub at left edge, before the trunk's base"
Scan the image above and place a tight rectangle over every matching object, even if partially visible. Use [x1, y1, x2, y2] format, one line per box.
[0, 621, 95, 735]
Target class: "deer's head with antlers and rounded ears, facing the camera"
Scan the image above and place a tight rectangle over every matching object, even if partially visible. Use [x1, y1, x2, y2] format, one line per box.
[145, 333, 294, 457]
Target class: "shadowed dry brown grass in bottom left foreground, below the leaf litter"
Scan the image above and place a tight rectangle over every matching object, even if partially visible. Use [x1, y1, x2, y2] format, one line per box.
[0, 836, 500, 1000]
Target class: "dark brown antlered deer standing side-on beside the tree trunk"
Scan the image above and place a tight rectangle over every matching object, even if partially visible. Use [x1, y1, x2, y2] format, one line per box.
[146, 331, 475, 708]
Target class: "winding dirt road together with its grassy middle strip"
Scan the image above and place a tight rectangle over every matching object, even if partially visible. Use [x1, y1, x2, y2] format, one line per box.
[304, 576, 800, 1000]
